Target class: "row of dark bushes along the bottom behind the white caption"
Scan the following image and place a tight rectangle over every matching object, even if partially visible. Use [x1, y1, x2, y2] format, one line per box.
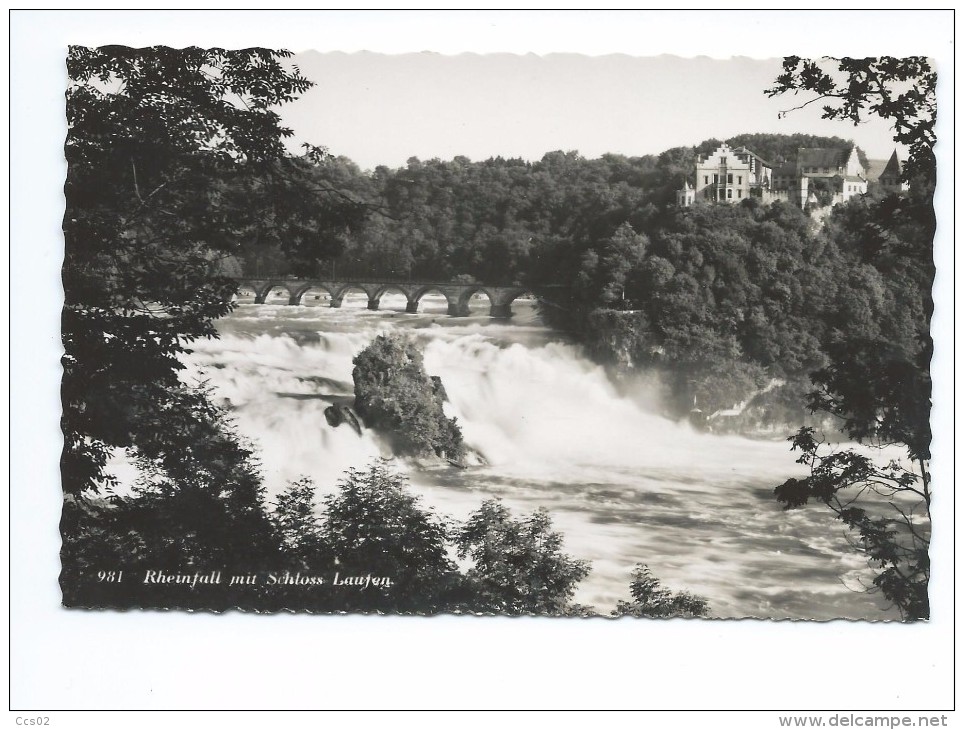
[64, 458, 616, 615]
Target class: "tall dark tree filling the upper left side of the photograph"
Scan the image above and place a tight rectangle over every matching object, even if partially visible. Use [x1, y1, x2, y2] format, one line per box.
[62, 46, 311, 494]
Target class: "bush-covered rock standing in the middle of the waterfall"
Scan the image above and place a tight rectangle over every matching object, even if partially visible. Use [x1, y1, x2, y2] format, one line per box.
[352, 334, 465, 462]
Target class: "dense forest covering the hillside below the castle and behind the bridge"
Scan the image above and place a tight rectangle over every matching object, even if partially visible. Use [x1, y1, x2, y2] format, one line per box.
[222, 129, 930, 426]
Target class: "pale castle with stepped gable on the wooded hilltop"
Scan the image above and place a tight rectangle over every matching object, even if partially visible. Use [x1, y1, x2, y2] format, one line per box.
[676, 143, 906, 210]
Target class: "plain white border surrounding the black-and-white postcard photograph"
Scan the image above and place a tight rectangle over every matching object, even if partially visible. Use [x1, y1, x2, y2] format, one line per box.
[10, 10, 953, 712]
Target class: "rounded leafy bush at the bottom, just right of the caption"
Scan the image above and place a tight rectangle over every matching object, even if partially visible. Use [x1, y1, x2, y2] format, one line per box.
[455, 499, 590, 615]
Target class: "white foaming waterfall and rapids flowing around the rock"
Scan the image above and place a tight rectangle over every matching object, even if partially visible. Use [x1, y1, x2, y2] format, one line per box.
[177, 295, 896, 619]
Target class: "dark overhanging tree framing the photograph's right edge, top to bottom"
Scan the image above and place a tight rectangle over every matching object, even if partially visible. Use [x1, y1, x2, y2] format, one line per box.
[766, 56, 936, 620]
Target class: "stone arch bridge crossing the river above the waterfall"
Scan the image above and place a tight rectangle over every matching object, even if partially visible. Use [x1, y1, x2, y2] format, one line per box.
[236, 277, 530, 318]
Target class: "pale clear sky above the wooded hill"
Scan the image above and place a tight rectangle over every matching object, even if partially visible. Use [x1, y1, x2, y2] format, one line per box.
[279, 51, 906, 169]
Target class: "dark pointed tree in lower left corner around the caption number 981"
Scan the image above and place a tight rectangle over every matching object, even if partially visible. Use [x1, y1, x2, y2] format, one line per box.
[60, 387, 278, 610]
